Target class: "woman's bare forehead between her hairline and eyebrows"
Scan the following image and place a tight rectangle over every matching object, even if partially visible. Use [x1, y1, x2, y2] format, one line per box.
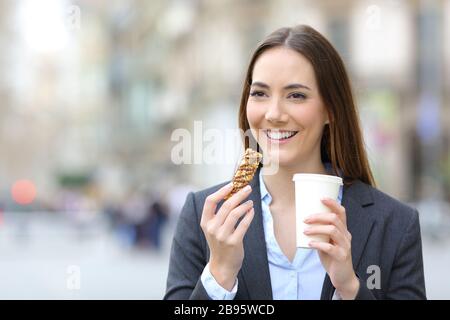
[252, 47, 315, 86]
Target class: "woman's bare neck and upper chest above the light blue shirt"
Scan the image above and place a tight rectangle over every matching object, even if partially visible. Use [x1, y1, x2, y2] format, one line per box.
[261, 161, 328, 206]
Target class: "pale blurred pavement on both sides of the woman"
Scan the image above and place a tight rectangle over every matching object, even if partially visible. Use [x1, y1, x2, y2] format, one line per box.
[0, 212, 450, 299]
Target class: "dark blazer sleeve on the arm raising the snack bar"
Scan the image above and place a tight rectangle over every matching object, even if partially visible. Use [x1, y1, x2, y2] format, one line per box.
[163, 192, 210, 300]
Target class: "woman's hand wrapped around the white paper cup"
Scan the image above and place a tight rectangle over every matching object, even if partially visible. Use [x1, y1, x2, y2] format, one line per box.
[304, 199, 359, 300]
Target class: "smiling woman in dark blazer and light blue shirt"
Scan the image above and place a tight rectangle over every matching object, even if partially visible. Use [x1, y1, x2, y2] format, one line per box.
[164, 25, 426, 299]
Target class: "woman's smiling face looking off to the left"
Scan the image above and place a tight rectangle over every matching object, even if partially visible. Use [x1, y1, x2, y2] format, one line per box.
[247, 47, 328, 167]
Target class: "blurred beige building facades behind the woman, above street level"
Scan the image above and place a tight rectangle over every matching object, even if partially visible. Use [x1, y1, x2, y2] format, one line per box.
[0, 0, 450, 208]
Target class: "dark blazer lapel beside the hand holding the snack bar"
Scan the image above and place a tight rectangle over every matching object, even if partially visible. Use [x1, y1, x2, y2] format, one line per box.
[241, 168, 273, 300]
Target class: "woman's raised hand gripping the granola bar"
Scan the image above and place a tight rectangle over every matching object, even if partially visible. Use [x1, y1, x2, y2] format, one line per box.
[200, 183, 255, 291]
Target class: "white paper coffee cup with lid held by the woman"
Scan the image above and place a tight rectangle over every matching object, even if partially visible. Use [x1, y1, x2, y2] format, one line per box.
[292, 173, 343, 248]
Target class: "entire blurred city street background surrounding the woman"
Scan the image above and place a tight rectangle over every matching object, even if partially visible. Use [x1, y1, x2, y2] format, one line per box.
[0, 0, 450, 299]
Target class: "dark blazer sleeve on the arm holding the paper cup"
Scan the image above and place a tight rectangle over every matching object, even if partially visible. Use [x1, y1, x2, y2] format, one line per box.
[356, 210, 426, 300]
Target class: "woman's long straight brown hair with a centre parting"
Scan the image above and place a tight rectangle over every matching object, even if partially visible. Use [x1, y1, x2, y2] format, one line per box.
[239, 25, 375, 187]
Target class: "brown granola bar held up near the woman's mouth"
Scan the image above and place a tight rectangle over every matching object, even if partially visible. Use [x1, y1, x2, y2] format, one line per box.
[225, 148, 262, 200]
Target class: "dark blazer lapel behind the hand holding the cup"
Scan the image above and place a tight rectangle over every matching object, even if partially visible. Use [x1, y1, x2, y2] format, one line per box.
[321, 180, 374, 300]
